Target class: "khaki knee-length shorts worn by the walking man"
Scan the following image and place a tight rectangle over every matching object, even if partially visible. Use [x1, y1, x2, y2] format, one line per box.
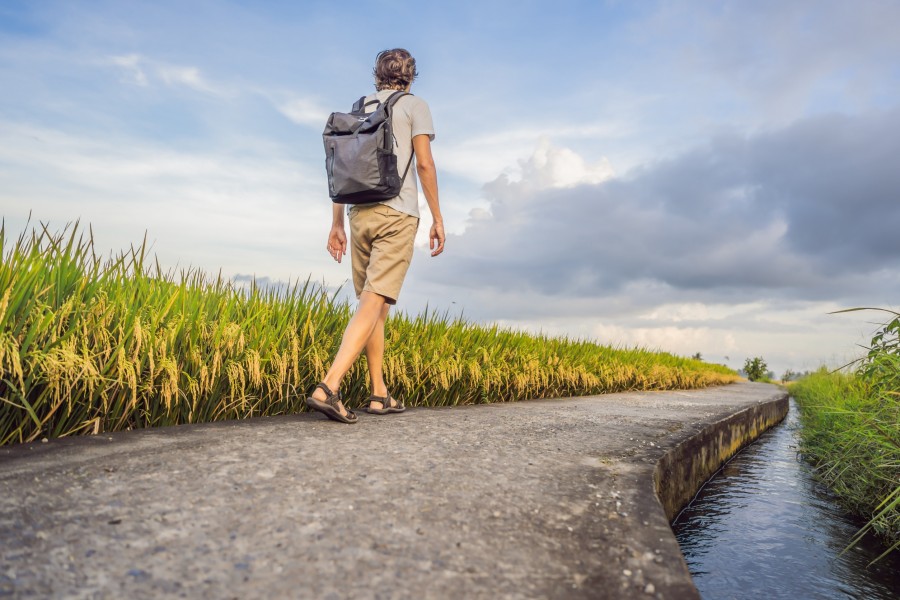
[350, 204, 419, 304]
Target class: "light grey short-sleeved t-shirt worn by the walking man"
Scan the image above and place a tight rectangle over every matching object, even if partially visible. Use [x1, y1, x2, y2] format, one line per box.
[366, 90, 434, 217]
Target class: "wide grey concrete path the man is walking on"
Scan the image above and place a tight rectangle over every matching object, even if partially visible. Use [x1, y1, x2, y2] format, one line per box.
[0, 383, 784, 599]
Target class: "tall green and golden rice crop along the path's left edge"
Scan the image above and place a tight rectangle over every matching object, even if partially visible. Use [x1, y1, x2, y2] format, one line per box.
[0, 224, 737, 444]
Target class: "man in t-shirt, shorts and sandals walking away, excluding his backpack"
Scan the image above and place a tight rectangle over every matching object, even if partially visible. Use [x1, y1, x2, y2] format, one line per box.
[306, 48, 444, 423]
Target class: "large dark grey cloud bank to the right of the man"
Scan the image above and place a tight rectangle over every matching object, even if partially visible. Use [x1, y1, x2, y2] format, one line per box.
[414, 109, 900, 308]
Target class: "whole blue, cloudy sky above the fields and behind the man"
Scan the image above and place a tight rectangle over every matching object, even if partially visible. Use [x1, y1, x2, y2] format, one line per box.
[0, 0, 900, 375]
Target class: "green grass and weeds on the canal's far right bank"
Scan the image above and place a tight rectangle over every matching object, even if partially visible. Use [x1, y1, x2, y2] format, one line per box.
[791, 311, 900, 554]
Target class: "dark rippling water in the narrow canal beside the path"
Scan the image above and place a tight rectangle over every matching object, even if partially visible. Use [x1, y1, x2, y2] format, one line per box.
[672, 399, 900, 600]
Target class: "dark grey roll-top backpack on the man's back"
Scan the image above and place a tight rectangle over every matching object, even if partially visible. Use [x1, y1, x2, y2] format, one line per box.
[322, 91, 412, 204]
